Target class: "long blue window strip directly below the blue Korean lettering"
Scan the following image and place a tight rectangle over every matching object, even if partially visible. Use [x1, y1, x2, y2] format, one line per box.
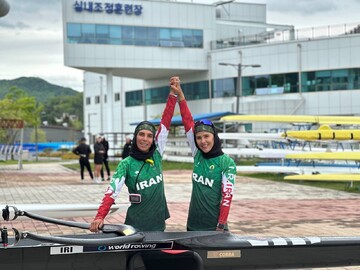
[66, 23, 204, 48]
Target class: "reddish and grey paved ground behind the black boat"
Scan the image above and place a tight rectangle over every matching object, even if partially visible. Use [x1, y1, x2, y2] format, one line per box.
[0, 163, 360, 269]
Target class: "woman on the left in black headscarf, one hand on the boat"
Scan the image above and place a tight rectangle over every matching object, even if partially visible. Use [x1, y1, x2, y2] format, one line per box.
[90, 78, 177, 232]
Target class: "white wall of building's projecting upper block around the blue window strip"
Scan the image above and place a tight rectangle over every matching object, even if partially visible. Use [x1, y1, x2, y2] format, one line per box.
[63, 0, 216, 78]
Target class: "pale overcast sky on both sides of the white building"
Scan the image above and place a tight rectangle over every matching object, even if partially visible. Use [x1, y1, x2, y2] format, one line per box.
[0, 0, 360, 91]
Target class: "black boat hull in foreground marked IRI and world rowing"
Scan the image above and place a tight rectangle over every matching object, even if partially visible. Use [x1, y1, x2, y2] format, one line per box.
[0, 232, 360, 270]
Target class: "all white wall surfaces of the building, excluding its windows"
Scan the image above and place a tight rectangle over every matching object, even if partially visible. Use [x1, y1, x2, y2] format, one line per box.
[63, 0, 360, 134]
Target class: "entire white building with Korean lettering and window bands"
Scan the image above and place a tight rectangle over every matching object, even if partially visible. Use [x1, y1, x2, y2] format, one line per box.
[62, 0, 360, 135]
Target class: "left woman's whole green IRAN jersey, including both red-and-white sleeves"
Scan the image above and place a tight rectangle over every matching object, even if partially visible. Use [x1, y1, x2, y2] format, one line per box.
[94, 94, 177, 231]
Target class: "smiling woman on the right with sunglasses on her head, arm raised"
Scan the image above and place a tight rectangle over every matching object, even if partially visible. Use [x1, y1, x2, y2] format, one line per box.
[170, 77, 236, 231]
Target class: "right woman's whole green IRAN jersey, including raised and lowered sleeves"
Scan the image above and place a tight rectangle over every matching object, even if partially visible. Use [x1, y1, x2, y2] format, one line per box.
[179, 99, 236, 231]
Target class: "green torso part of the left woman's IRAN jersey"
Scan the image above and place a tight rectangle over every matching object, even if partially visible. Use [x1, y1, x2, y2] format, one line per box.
[110, 151, 170, 231]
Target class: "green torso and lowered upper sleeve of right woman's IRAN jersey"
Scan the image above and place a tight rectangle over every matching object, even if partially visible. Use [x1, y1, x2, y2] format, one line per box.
[187, 151, 236, 231]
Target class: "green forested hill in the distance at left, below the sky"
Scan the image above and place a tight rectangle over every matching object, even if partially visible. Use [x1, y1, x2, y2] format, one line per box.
[0, 77, 79, 103]
